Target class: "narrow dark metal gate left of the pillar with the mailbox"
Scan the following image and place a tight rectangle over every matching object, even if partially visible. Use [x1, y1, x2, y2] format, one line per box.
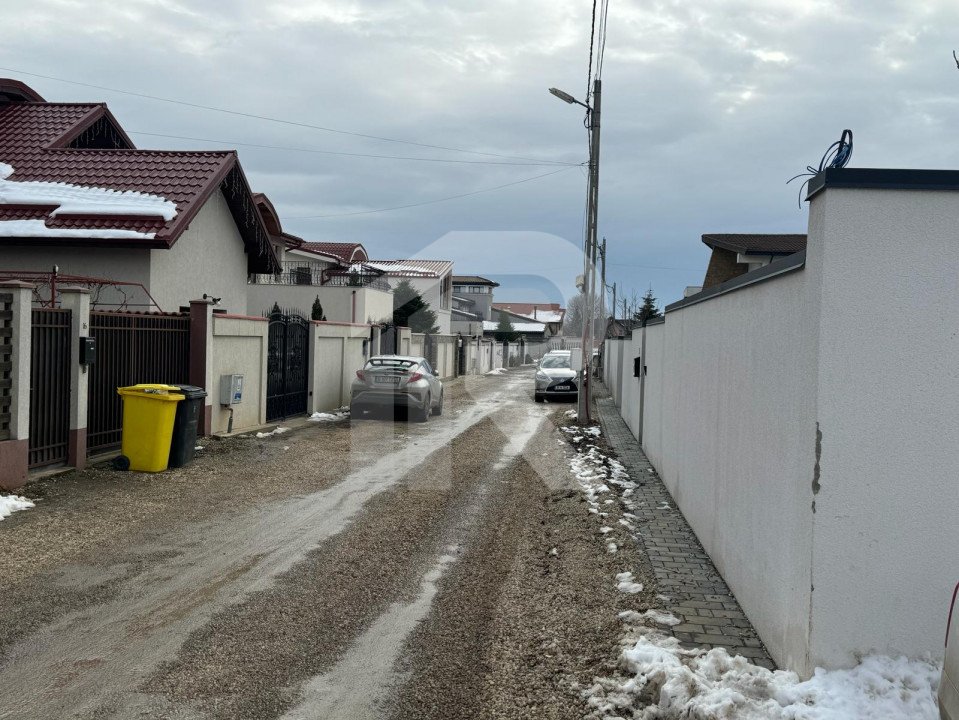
[27, 308, 70, 468]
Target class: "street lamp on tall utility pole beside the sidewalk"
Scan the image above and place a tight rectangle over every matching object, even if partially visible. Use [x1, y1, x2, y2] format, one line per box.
[549, 79, 602, 423]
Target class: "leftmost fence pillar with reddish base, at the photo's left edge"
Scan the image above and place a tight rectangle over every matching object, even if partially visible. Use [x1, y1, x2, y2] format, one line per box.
[0, 281, 33, 490]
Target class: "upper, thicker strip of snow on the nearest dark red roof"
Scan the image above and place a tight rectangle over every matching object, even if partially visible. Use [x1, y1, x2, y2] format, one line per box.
[0, 162, 177, 221]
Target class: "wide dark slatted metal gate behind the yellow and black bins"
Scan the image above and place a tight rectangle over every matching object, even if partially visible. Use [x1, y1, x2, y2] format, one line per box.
[87, 312, 190, 455]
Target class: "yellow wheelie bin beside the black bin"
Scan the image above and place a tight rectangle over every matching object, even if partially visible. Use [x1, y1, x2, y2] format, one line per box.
[114, 385, 184, 472]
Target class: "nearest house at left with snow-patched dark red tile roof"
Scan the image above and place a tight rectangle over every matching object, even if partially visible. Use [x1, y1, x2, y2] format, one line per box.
[0, 80, 280, 313]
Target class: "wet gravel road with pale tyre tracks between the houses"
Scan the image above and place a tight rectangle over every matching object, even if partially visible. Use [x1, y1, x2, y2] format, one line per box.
[0, 369, 653, 720]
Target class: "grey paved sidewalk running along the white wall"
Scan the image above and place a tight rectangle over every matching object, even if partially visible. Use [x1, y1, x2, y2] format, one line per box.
[594, 390, 775, 669]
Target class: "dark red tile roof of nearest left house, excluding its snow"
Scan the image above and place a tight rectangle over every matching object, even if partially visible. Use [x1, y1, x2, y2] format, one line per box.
[0, 86, 277, 272]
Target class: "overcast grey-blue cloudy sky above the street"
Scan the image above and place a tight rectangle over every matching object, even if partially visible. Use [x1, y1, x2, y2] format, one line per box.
[0, 0, 959, 302]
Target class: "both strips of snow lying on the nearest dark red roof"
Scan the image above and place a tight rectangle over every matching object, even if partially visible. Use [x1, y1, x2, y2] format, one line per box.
[0, 162, 177, 239]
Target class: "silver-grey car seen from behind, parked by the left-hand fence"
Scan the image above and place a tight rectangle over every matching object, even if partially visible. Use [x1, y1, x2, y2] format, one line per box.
[350, 355, 443, 422]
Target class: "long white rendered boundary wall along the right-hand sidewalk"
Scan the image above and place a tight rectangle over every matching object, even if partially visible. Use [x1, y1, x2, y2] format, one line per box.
[606, 177, 959, 675]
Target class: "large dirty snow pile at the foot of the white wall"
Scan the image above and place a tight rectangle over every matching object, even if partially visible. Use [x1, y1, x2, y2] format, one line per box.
[584, 624, 940, 720]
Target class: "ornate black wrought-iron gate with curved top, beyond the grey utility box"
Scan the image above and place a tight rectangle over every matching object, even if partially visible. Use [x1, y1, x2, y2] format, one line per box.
[266, 305, 310, 421]
